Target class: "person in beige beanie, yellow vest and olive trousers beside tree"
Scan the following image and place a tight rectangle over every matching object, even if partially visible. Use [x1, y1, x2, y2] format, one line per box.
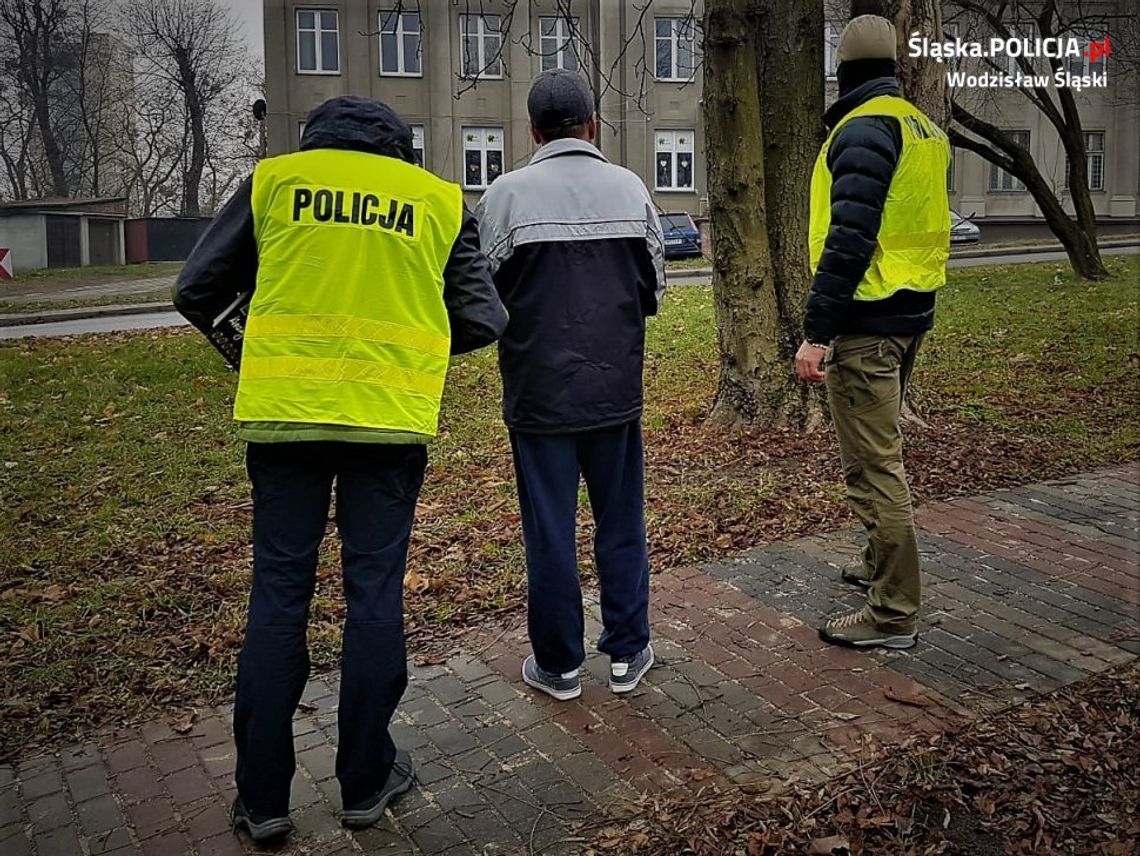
[796, 15, 950, 649]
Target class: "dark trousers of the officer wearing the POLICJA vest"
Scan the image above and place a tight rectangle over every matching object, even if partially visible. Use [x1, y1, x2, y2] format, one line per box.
[234, 442, 428, 817]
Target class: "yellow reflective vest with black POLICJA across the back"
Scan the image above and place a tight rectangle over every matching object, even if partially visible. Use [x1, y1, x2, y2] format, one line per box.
[234, 149, 463, 437]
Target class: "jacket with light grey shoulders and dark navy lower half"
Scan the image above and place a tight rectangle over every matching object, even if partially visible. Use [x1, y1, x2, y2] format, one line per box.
[475, 139, 665, 433]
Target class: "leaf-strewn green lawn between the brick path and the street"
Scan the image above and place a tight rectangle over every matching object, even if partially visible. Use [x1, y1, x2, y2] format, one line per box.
[0, 256, 1140, 757]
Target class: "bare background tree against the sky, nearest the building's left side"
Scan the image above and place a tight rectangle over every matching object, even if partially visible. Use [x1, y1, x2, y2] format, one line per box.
[121, 0, 252, 217]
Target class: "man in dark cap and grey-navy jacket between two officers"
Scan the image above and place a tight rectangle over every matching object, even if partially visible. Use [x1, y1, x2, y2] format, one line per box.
[475, 70, 665, 700]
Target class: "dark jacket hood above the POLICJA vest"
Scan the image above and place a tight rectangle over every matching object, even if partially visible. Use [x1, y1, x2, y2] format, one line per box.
[301, 95, 415, 163]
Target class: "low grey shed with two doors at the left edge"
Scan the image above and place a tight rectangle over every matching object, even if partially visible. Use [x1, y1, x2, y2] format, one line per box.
[0, 196, 127, 274]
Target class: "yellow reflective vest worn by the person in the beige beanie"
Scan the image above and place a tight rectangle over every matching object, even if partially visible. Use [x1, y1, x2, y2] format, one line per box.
[808, 96, 950, 300]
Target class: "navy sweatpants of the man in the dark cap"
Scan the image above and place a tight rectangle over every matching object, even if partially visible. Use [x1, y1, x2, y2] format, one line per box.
[511, 419, 649, 672]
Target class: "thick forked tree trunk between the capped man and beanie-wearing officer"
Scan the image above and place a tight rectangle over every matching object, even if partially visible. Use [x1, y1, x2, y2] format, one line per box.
[705, 0, 823, 427]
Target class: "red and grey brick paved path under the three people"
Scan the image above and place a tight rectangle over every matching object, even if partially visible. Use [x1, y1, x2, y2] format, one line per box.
[0, 466, 1140, 856]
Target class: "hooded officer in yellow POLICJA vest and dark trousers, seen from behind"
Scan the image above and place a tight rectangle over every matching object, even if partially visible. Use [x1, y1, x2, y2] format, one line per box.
[174, 97, 506, 841]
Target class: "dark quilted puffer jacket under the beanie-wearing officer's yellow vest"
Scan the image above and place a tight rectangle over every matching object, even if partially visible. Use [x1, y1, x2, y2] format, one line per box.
[804, 78, 935, 345]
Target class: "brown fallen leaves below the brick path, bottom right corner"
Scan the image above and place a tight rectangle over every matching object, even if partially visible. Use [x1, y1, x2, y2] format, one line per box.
[595, 662, 1140, 856]
